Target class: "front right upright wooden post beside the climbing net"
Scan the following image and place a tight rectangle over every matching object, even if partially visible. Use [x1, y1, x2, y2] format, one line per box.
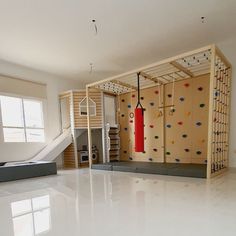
[207, 45, 216, 179]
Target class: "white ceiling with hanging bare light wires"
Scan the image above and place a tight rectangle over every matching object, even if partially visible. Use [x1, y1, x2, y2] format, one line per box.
[0, 0, 236, 82]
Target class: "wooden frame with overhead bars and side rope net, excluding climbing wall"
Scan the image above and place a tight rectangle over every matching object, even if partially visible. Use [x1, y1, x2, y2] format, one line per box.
[86, 44, 232, 179]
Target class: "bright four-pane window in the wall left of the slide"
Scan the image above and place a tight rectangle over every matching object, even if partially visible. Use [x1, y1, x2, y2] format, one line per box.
[0, 96, 45, 142]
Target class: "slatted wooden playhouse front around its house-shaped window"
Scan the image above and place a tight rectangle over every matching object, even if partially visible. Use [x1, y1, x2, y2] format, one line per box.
[73, 91, 102, 128]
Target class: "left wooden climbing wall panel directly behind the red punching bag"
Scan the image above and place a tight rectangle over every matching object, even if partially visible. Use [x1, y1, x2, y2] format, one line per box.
[118, 86, 164, 162]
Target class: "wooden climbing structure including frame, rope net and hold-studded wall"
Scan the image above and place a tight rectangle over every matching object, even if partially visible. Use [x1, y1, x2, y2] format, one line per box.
[86, 45, 231, 178]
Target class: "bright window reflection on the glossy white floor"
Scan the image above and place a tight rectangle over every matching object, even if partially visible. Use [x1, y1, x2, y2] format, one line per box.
[11, 195, 51, 236]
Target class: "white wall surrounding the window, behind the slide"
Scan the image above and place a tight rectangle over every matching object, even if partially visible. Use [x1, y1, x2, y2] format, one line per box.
[0, 61, 80, 162]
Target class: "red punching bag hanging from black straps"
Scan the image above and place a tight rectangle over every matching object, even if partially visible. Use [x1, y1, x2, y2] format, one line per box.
[134, 73, 144, 152]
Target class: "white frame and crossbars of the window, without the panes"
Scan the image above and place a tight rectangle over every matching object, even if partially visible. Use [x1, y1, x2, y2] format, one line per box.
[0, 92, 46, 143]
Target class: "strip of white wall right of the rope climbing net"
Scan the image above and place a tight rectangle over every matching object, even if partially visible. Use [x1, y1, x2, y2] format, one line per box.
[217, 37, 236, 167]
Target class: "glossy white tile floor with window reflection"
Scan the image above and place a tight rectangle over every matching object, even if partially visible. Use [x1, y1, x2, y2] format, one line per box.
[0, 169, 236, 236]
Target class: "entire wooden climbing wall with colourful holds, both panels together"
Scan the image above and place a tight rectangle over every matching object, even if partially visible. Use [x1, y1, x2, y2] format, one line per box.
[118, 74, 209, 164]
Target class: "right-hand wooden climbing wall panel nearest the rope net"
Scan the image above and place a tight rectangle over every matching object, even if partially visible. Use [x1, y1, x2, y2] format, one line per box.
[165, 75, 209, 163]
